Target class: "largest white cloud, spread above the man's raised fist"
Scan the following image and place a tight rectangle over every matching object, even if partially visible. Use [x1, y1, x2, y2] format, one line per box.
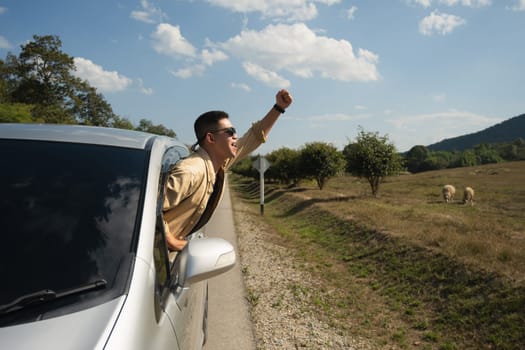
[217, 23, 379, 81]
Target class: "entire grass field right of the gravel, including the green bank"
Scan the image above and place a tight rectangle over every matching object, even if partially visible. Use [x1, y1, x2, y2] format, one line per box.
[232, 162, 525, 349]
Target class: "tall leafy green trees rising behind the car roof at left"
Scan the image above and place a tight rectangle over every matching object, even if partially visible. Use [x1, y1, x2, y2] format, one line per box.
[0, 35, 175, 137]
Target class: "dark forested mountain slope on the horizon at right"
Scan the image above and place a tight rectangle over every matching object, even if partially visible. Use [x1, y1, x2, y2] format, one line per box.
[427, 114, 525, 151]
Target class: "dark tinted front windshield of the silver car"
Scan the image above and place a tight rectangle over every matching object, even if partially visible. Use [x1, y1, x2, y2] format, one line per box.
[0, 139, 147, 314]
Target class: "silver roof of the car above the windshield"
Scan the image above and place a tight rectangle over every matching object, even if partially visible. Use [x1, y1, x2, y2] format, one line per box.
[0, 124, 172, 149]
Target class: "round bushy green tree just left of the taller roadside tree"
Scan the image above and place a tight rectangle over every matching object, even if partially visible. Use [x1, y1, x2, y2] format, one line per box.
[299, 142, 345, 190]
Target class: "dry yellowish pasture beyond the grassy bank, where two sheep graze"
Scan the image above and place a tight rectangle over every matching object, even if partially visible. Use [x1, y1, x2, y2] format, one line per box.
[284, 162, 525, 284]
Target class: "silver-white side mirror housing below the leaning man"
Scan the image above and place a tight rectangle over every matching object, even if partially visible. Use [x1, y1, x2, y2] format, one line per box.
[174, 237, 236, 287]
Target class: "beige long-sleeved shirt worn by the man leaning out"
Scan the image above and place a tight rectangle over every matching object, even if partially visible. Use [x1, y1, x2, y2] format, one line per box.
[163, 121, 266, 239]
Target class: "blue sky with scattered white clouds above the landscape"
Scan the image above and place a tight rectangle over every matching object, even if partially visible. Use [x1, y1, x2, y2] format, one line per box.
[0, 0, 525, 154]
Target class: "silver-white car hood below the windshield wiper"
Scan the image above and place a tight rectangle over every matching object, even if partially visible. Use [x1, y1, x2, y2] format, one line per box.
[0, 296, 125, 350]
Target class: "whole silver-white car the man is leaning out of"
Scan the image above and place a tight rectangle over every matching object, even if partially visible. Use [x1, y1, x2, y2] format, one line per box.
[0, 124, 235, 350]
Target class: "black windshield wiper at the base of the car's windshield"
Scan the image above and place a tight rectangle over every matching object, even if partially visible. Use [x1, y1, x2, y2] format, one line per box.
[0, 279, 108, 315]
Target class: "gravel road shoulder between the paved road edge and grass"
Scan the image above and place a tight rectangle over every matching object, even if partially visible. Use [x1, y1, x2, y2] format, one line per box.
[232, 200, 374, 350]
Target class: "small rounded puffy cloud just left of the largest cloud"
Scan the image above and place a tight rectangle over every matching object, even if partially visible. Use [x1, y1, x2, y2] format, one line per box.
[151, 23, 196, 57]
